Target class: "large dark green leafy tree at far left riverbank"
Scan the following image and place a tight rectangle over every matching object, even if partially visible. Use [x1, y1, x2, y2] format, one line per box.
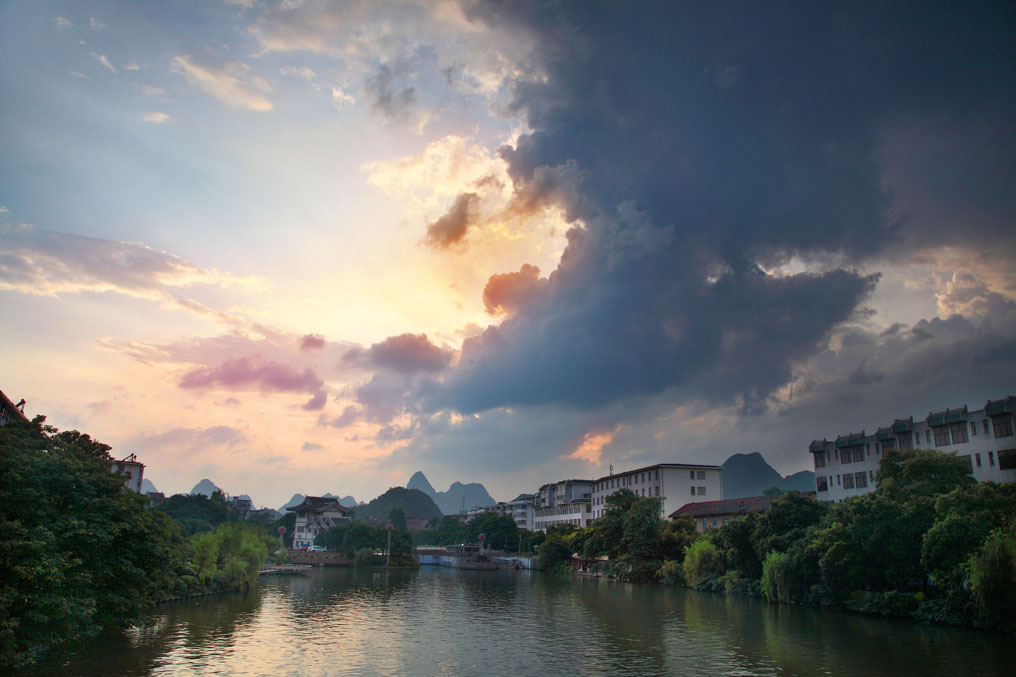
[0, 417, 187, 669]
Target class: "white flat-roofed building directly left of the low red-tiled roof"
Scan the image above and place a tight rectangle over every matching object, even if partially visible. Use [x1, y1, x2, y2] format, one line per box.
[592, 464, 723, 518]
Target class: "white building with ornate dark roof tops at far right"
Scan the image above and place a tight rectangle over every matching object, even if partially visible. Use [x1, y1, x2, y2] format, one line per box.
[808, 395, 1016, 502]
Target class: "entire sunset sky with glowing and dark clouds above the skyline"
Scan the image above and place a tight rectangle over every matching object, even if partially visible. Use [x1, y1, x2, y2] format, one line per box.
[0, 0, 1016, 507]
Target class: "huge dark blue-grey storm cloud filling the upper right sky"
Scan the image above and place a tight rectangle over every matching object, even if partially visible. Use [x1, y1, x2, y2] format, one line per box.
[416, 3, 1016, 412]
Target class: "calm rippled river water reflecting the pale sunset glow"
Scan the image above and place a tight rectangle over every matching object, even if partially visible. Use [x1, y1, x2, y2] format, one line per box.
[33, 567, 1016, 676]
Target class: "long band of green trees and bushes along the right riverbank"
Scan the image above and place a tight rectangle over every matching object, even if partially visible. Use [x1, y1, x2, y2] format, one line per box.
[541, 449, 1016, 632]
